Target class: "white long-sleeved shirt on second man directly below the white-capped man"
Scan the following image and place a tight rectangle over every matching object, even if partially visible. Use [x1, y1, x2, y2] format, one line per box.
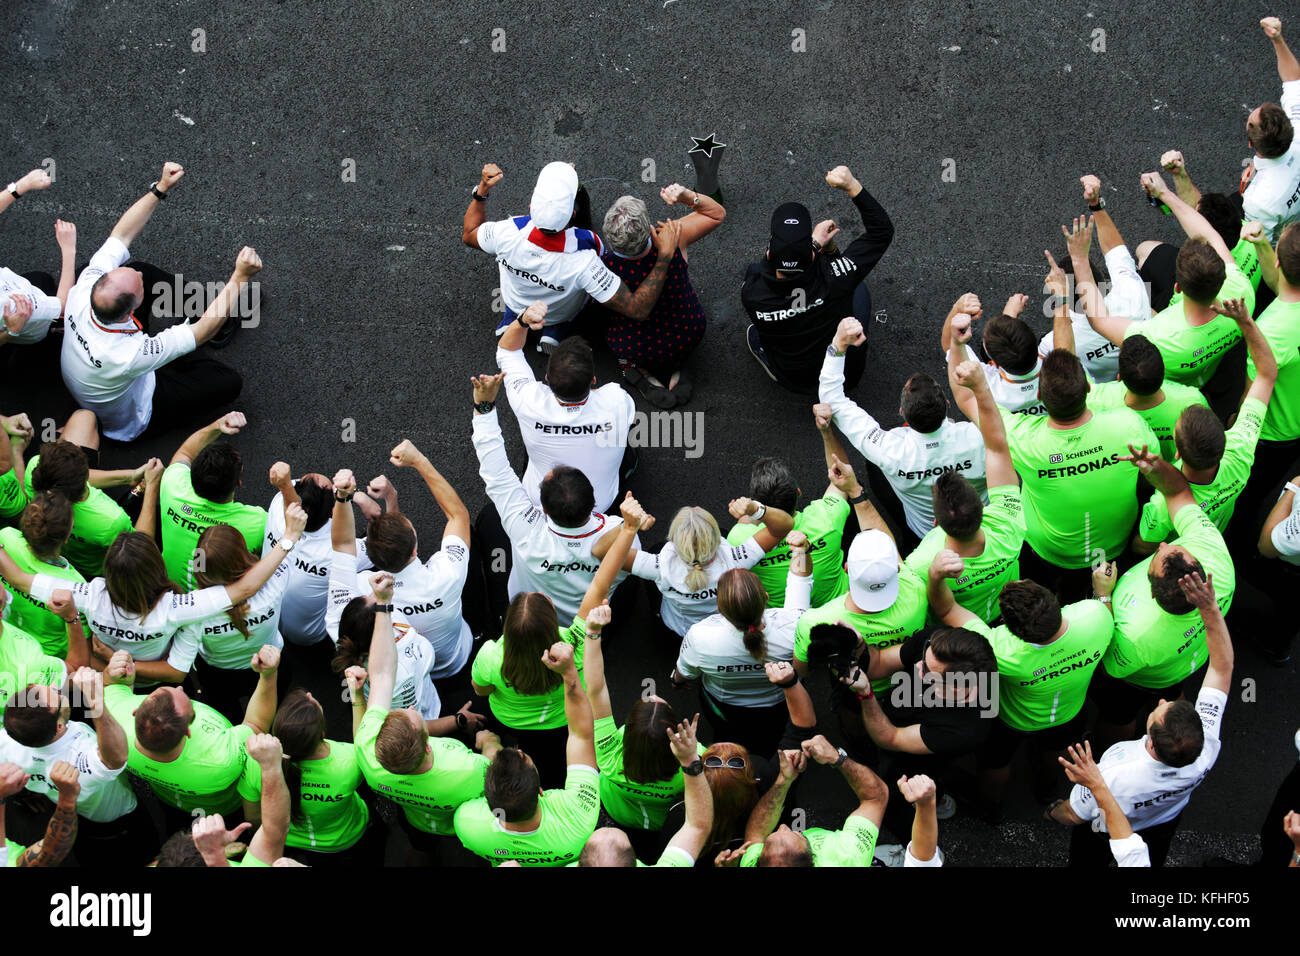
[473, 411, 638, 620]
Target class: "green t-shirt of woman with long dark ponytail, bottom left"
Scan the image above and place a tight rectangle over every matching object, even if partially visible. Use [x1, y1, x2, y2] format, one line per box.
[239, 740, 371, 853]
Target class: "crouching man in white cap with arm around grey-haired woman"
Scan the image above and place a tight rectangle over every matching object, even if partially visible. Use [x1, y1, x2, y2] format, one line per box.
[460, 163, 679, 352]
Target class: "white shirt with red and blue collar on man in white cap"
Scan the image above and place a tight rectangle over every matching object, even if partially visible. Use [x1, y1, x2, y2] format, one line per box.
[475, 216, 623, 325]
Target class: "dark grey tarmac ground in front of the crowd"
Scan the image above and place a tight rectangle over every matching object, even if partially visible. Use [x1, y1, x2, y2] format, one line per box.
[0, 0, 1297, 864]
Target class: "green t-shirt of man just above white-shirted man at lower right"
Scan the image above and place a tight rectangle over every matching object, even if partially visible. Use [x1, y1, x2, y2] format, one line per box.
[1101, 505, 1236, 691]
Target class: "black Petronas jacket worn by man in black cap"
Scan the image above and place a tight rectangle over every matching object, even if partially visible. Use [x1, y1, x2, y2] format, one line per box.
[740, 189, 893, 392]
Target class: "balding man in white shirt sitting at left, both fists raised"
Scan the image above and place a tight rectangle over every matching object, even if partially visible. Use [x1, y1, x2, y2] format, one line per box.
[62, 163, 261, 441]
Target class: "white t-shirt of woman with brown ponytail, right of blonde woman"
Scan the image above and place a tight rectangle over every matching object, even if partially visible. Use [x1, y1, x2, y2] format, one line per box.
[677, 571, 813, 708]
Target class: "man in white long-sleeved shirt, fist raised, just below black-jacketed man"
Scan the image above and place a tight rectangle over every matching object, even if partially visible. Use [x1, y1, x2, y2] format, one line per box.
[818, 316, 988, 554]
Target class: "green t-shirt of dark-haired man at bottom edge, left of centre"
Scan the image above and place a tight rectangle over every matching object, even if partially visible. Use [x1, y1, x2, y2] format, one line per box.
[455, 765, 601, 866]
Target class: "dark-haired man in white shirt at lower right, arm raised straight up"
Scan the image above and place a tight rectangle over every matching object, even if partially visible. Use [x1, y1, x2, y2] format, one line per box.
[1047, 567, 1232, 868]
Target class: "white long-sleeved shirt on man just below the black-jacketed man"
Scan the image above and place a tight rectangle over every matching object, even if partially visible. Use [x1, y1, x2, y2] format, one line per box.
[818, 351, 988, 537]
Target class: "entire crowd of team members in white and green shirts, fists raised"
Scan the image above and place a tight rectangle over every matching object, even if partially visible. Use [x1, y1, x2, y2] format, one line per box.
[0, 17, 1300, 868]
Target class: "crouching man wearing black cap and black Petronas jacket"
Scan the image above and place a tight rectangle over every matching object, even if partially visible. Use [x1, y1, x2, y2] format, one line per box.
[740, 166, 893, 394]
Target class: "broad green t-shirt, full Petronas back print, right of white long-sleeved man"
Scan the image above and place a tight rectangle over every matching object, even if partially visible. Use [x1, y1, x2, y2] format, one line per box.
[1001, 405, 1158, 568]
